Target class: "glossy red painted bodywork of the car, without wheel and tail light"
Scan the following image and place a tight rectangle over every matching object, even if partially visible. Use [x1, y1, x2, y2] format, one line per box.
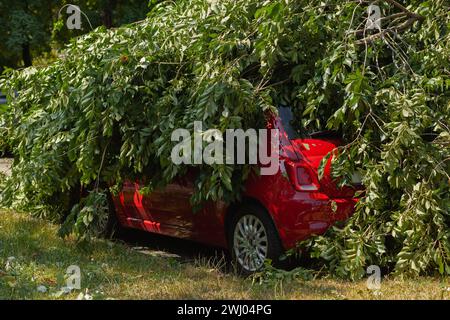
[113, 112, 358, 249]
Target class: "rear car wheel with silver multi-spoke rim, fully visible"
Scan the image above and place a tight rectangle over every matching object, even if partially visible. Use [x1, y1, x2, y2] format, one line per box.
[228, 205, 283, 275]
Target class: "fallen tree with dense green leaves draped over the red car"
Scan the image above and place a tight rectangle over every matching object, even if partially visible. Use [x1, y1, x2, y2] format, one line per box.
[1, 0, 450, 278]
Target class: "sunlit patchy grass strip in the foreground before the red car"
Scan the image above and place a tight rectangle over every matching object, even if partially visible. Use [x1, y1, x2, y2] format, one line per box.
[0, 211, 450, 299]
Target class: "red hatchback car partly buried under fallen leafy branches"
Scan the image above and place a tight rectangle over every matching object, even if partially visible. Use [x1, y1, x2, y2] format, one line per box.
[113, 107, 357, 273]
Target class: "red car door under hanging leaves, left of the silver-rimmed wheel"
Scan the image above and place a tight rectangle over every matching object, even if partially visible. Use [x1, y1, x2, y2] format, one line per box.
[121, 168, 227, 246]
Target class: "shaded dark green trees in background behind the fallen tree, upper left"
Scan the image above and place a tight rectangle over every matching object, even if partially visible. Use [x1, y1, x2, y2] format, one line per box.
[0, 0, 148, 73]
